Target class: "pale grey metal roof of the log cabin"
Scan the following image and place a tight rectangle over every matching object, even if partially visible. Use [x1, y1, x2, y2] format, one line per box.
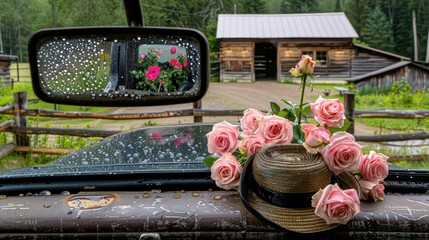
[216, 12, 359, 39]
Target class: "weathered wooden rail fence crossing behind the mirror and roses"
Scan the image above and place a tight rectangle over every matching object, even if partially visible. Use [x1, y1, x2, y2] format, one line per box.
[0, 92, 429, 162]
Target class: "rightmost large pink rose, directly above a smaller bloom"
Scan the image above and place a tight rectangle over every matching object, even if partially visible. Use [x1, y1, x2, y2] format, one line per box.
[359, 151, 389, 183]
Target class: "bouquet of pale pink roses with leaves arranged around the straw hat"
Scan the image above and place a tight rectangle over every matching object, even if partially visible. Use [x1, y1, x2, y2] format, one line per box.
[204, 55, 388, 223]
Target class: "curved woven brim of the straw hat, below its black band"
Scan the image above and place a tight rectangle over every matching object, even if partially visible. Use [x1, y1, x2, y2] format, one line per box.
[239, 156, 359, 233]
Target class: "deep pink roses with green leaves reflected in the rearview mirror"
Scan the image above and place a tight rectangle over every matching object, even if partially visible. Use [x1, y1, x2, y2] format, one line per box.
[131, 47, 189, 92]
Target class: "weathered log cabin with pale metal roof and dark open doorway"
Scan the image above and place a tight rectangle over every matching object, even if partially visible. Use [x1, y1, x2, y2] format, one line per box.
[216, 12, 429, 90]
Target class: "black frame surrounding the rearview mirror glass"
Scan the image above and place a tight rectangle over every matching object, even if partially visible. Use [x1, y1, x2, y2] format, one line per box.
[28, 27, 210, 106]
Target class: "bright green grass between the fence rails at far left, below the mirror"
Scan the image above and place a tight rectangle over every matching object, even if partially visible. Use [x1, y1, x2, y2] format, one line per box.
[0, 63, 111, 169]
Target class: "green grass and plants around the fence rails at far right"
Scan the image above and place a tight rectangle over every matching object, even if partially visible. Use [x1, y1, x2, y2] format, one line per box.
[355, 82, 429, 169]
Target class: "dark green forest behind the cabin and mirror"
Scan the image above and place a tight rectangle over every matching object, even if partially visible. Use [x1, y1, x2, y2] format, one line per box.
[0, 0, 429, 62]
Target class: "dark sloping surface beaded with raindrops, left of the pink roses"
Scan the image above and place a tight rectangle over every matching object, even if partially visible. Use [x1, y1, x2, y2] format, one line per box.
[0, 125, 212, 178]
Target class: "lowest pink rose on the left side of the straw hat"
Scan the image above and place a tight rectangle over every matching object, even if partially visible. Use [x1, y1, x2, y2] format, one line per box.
[210, 153, 243, 190]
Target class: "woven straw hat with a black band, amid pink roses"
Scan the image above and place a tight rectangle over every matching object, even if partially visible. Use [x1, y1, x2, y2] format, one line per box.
[239, 144, 360, 233]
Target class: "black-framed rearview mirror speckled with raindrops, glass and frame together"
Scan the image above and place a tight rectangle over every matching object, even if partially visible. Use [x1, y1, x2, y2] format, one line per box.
[29, 27, 209, 106]
